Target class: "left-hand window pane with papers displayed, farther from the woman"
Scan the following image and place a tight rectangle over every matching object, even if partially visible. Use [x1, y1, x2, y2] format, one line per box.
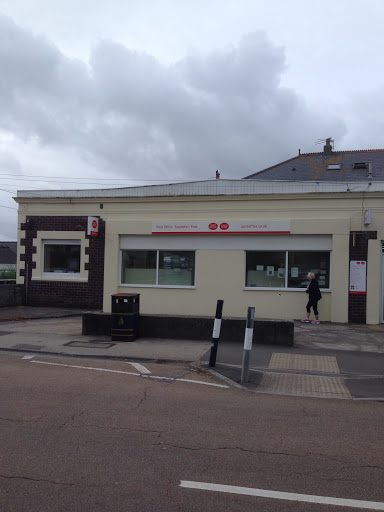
[245, 251, 286, 288]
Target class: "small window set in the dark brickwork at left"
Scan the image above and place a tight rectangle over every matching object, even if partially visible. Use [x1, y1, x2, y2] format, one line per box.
[43, 240, 81, 278]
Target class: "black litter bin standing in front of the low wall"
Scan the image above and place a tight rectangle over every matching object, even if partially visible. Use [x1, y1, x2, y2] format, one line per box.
[111, 293, 140, 341]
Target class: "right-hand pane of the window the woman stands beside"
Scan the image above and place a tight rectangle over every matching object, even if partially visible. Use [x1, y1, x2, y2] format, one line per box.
[288, 251, 330, 288]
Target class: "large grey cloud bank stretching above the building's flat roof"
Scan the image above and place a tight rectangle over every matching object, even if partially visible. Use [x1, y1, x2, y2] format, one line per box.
[0, 17, 346, 180]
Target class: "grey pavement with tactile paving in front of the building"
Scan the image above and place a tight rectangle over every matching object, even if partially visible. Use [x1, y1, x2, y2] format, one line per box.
[0, 306, 384, 401]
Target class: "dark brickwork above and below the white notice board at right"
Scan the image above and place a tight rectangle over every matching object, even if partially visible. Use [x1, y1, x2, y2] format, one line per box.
[348, 231, 377, 324]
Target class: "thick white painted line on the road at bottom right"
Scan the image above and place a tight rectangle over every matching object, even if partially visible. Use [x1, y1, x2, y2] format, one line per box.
[180, 480, 384, 510]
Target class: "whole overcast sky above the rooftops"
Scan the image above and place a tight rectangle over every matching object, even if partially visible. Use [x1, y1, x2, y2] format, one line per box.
[0, 0, 384, 240]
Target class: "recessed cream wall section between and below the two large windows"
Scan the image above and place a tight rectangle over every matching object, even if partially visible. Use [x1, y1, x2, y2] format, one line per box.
[104, 250, 331, 320]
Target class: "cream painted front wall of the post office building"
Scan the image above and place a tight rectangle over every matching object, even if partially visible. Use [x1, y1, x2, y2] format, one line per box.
[18, 192, 384, 323]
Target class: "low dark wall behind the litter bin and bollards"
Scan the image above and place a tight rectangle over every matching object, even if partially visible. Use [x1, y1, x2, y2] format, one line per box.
[83, 312, 294, 346]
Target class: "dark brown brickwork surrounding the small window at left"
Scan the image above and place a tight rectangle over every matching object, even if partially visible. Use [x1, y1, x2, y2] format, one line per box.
[20, 216, 105, 309]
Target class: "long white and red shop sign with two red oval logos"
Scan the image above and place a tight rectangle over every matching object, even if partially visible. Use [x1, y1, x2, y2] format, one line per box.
[152, 220, 291, 235]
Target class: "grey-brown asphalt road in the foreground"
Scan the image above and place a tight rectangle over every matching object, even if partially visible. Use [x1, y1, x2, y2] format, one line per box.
[0, 353, 384, 512]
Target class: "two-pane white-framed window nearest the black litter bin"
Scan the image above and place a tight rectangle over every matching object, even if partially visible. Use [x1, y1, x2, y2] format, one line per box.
[121, 249, 195, 287]
